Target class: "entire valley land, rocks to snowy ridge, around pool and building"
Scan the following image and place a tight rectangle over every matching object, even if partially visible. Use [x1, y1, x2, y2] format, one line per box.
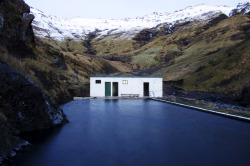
[0, 0, 250, 164]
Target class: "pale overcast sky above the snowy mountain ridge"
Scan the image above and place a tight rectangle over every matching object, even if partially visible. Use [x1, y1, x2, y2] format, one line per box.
[24, 0, 247, 19]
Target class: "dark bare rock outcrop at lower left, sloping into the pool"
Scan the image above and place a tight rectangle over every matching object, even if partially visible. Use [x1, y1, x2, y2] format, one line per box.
[0, 61, 66, 161]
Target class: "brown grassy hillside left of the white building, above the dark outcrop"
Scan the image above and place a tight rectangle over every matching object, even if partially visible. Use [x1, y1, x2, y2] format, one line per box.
[0, 38, 131, 103]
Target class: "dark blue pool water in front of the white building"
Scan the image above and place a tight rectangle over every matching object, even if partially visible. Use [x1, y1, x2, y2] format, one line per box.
[11, 100, 250, 166]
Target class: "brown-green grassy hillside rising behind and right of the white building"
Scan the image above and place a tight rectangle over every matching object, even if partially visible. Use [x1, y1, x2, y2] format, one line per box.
[93, 14, 250, 104]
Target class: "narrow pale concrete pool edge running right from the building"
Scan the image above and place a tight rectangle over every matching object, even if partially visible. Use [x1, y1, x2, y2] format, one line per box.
[150, 98, 250, 122]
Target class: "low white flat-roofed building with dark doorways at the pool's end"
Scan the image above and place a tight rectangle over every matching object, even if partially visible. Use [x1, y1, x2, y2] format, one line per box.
[90, 76, 163, 97]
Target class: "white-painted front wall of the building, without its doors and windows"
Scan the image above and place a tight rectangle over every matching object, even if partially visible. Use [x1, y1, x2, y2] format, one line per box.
[90, 77, 163, 97]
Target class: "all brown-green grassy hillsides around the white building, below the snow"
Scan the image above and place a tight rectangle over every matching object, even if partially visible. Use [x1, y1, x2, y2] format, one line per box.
[1, 10, 250, 105]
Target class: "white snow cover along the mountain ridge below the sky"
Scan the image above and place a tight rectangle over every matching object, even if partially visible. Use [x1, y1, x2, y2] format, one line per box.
[31, 5, 233, 40]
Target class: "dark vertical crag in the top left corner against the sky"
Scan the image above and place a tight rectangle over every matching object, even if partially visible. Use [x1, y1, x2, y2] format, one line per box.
[0, 0, 34, 58]
